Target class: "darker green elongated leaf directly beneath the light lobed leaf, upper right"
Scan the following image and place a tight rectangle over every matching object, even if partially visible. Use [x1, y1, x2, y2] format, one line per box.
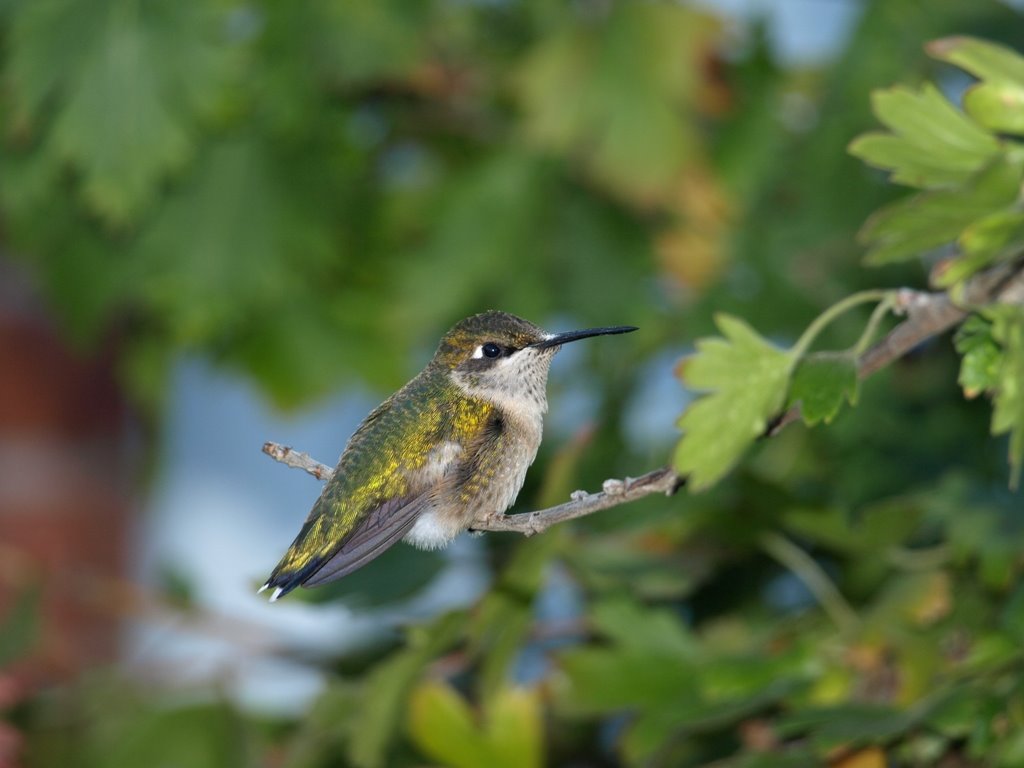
[859, 154, 1024, 264]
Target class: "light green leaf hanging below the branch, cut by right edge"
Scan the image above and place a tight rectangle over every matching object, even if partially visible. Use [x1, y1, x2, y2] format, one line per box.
[990, 306, 1024, 489]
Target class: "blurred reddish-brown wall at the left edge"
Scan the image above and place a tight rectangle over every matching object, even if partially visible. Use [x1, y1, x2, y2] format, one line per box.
[0, 260, 138, 689]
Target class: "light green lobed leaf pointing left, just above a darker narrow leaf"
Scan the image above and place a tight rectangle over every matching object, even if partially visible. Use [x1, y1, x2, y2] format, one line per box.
[850, 84, 999, 189]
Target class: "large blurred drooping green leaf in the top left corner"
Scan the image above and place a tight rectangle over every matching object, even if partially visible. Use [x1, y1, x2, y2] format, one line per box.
[10, 0, 232, 226]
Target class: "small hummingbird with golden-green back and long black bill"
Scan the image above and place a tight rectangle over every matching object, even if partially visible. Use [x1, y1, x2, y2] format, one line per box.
[259, 310, 637, 602]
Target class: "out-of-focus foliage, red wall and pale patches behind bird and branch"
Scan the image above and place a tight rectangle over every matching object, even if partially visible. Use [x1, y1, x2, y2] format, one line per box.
[0, 0, 1024, 768]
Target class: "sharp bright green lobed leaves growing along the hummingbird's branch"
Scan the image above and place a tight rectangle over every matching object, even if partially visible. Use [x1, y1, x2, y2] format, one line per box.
[674, 38, 1024, 489]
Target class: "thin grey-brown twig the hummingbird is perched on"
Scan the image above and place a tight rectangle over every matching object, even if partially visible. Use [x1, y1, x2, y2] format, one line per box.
[263, 262, 1024, 536]
